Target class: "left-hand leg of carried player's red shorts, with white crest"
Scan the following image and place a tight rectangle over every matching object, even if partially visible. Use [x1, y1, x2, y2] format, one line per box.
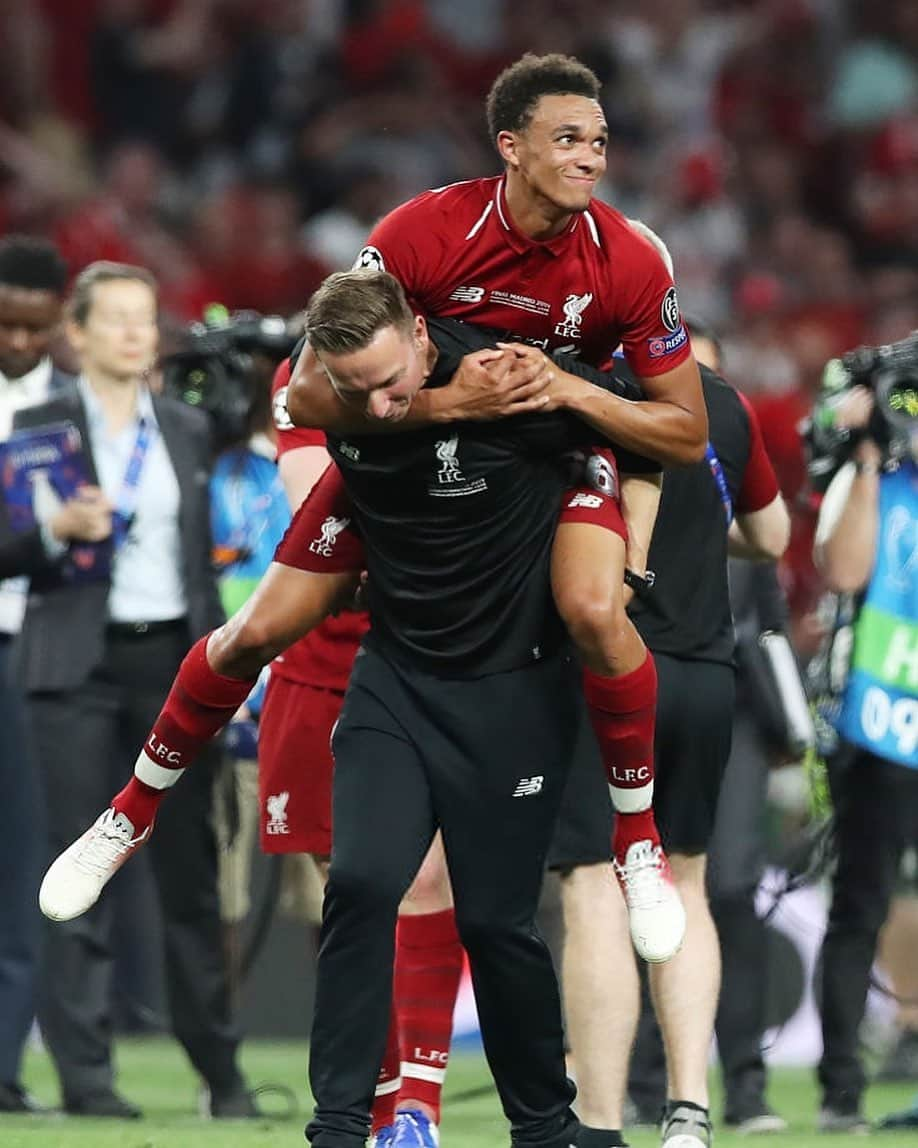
[274, 463, 366, 574]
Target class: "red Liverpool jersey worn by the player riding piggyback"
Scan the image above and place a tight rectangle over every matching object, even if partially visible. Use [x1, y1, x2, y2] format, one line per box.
[355, 177, 691, 378]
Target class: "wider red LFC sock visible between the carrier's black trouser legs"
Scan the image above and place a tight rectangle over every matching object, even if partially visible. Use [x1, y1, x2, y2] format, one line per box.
[395, 909, 462, 1124]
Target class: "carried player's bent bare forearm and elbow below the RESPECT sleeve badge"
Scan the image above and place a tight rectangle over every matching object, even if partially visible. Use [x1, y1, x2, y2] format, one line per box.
[565, 358, 708, 466]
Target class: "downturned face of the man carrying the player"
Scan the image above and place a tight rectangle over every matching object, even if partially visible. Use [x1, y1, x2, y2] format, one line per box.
[317, 316, 430, 422]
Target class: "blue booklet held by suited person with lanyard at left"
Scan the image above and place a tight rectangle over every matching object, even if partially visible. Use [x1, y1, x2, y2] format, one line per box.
[0, 422, 112, 582]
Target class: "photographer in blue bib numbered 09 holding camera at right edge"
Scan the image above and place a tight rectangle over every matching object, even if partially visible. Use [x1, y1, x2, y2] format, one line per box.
[810, 333, 918, 1132]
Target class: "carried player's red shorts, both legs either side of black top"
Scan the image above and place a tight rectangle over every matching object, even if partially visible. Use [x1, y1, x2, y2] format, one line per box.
[274, 447, 628, 574]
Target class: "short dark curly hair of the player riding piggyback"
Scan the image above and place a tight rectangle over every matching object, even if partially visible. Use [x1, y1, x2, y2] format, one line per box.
[487, 52, 601, 139]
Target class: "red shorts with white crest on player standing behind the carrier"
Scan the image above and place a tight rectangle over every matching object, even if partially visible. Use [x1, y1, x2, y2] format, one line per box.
[258, 676, 344, 855]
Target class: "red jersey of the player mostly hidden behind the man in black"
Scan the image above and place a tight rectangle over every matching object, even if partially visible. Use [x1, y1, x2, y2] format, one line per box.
[271, 360, 369, 692]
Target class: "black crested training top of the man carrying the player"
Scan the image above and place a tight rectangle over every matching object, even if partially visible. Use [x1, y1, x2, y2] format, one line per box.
[327, 318, 638, 677]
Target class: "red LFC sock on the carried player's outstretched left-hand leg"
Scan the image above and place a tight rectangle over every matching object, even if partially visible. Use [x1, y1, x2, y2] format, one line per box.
[111, 637, 255, 833]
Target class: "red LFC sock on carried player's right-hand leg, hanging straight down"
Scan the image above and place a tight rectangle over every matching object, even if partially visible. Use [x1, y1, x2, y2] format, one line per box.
[583, 651, 660, 861]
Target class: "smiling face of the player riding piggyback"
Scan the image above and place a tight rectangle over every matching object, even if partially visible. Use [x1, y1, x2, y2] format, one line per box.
[500, 95, 608, 212]
